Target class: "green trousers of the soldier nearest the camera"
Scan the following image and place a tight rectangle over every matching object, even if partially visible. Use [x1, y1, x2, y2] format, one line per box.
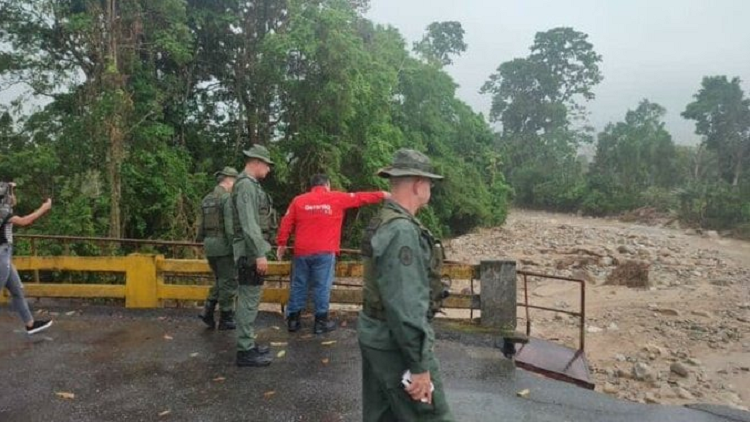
[359, 343, 455, 422]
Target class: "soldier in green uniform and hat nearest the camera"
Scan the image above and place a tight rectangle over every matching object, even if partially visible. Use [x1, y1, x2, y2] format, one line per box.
[357, 149, 454, 422]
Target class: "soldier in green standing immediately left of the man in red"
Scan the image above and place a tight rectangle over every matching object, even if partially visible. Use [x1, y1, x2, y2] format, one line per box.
[232, 145, 276, 366]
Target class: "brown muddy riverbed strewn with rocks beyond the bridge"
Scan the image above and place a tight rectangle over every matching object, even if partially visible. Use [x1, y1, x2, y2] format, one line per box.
[446, 210, 750, 409]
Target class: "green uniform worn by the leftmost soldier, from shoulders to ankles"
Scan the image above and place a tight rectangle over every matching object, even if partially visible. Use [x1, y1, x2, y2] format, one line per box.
[200, 185, 237, 312]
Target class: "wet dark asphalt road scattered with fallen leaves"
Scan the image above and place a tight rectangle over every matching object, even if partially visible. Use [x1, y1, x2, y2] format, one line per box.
[0, 305, 750, 422]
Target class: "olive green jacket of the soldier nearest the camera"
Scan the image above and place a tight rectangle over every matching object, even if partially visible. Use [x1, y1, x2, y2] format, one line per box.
[357, 201, 435, 374]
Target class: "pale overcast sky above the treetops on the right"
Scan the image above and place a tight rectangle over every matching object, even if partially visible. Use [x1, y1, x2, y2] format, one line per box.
[367, 0, 750, 143]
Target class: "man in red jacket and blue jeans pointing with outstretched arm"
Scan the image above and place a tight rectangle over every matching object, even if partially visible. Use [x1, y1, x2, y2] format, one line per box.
[276, 174, 390, 334]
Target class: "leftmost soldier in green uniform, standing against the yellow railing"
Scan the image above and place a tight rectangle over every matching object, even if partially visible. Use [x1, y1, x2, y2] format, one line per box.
[198, 167, 238, 330]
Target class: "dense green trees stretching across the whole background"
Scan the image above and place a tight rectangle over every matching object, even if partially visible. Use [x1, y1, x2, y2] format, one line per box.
[0, 0, 750, 251]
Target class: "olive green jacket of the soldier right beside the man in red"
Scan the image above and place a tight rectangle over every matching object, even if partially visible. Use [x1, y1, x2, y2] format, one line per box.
[232, 171, 271, 261]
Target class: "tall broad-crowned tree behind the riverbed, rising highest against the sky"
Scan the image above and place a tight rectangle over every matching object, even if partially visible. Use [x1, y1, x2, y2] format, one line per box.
[481, 28, 602, 210]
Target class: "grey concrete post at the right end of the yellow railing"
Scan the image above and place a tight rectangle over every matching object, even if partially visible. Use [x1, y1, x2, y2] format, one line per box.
[479, 260, 516, 332]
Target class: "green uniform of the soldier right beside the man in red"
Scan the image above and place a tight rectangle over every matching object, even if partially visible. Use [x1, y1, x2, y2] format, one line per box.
[232, 171, 275, 352]
